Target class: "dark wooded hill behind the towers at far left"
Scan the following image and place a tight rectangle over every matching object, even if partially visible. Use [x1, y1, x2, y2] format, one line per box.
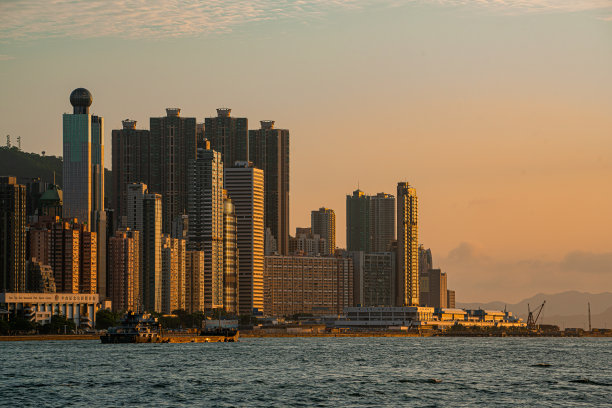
[0, 147, 113, 202]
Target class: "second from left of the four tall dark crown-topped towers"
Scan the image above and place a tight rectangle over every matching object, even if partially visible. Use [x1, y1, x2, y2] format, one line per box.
[149, 108, 197, 234]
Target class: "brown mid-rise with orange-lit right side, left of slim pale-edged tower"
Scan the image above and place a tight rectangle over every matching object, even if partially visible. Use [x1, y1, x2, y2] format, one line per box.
[108, 228, 142, 311]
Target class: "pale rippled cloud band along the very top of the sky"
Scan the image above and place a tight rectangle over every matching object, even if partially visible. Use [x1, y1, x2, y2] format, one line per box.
[0, 0, 612, 40]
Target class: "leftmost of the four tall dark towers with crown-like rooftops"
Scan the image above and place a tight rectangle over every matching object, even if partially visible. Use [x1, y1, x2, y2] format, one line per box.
[112, 119, 155, 227]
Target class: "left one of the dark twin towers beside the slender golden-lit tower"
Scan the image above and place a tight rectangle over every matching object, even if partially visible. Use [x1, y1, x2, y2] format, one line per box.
[346, 190, 372, 252]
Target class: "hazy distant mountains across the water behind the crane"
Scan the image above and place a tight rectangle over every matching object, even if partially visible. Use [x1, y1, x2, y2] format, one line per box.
[457, 291, 612, 328]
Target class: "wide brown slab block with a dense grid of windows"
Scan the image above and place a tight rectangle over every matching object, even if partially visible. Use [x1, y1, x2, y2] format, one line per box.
[264, 255, 353, 316]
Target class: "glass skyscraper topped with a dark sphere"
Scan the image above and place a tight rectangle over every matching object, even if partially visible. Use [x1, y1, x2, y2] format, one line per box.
[63, 88, 106, 299]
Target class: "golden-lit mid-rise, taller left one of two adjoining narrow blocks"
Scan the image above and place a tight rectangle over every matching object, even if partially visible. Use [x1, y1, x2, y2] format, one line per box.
[161, 235, 185, 313]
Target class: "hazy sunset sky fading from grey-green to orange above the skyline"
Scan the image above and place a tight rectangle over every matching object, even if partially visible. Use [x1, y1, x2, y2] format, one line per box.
[0, 0, 612, 302]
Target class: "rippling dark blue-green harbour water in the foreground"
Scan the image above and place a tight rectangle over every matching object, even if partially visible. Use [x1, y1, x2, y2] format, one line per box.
[0, 337, 612, 407]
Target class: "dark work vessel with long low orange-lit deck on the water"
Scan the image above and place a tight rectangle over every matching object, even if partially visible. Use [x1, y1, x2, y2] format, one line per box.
[100, 312, 238, 344]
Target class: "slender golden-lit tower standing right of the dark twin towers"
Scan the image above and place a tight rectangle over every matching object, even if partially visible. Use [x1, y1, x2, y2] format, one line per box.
[396, 182, 419, 306]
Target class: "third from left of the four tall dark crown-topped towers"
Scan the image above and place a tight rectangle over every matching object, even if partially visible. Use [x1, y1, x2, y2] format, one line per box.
[204, 108, 249, 167]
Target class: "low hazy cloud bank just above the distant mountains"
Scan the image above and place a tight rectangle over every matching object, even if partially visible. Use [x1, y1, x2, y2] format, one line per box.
[434, 242, 612, 302]
